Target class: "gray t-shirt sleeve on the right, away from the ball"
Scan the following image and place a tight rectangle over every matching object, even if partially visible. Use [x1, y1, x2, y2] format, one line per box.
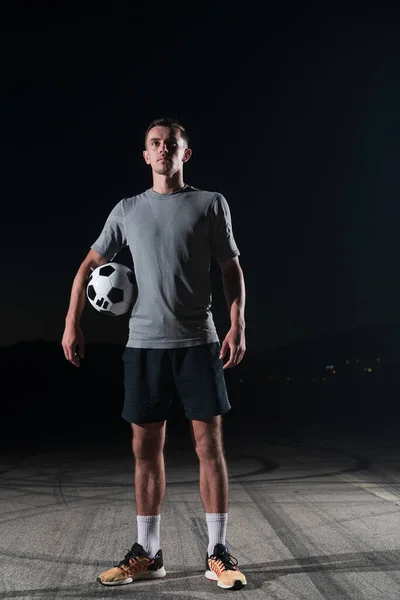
[210, 194, 240, 262]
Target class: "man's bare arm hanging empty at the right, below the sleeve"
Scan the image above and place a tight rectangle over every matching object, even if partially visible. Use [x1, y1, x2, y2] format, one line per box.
[219, 256, 246, 369]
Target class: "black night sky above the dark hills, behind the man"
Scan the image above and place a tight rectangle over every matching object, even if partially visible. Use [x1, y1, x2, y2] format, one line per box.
[0, 2, 400, 348]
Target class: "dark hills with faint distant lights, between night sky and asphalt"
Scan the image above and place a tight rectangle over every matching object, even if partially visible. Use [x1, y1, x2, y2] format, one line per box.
[0, 322, 400, 451]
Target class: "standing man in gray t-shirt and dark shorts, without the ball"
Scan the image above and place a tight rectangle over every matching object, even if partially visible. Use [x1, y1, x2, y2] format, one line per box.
[62, 118, 246, 589]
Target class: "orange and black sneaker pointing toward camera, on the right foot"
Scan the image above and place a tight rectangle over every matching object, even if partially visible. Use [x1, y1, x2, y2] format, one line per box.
[205, 544, 247, 590]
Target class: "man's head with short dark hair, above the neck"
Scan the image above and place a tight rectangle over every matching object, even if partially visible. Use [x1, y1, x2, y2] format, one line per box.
[143, 126, 191, 176]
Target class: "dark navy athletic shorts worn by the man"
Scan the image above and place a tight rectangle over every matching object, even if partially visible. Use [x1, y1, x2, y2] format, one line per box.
[122, 342, 231, 425]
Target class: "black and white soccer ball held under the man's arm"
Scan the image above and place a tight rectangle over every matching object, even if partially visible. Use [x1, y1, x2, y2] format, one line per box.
[86, 262, 135, 317]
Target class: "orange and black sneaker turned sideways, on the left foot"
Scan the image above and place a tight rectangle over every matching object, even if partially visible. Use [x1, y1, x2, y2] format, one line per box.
[97, 543, 166, 585]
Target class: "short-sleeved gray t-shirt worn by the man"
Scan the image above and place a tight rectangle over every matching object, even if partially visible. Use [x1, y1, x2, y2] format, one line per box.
[91, 185, 240, 348]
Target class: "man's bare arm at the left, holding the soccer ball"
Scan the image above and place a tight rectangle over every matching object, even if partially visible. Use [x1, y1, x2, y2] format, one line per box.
[61, 250, 108, 367]
